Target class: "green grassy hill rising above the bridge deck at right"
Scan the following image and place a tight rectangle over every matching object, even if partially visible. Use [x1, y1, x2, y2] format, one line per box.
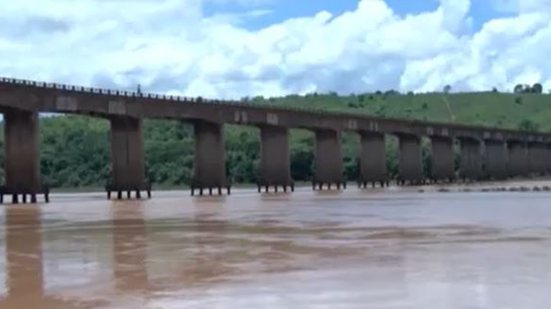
[250, 92, 551, 132]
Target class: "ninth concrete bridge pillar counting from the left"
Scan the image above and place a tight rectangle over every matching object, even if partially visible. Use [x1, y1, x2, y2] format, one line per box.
[459, 139, 483, 181]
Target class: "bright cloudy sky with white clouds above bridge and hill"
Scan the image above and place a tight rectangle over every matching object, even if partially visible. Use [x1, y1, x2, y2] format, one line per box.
[0, 0, 551, 98]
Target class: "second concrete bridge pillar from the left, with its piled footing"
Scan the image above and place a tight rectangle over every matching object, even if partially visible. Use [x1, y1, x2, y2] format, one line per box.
[106, 117, 151, 199]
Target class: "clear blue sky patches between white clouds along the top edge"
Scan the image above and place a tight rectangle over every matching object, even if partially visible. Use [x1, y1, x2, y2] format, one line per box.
[204, 0, 513, 31]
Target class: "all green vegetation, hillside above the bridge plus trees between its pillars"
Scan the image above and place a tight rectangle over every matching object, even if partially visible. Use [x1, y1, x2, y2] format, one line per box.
[0, 91, 551, 188]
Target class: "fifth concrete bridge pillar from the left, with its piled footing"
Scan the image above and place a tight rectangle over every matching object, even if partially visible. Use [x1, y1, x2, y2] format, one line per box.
[312, 130, 346, 189]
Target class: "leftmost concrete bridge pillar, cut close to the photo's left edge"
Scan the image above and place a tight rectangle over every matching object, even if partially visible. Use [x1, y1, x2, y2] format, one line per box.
[0, 110, 49, 204]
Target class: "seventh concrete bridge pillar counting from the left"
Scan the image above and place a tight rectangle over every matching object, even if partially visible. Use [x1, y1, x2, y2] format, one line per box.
[398, 135, 423, 184]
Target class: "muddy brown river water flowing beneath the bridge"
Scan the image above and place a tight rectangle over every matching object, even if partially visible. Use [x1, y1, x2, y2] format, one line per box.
[0, 184, 551, 309]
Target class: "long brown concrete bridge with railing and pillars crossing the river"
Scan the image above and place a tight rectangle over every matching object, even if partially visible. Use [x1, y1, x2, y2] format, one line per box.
[0, 78, 551, 203]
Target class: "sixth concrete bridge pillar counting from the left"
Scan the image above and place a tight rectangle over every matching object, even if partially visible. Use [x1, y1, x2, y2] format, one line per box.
[359, 132, 388, 188]
